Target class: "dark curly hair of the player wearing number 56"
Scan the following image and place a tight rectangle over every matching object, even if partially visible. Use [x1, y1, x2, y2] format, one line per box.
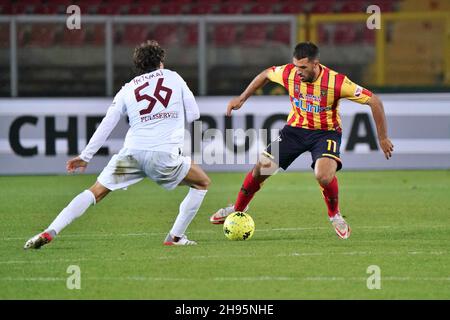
[133, 40, 166, 74]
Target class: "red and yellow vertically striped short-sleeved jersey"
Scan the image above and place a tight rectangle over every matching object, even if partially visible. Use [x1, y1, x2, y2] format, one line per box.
[268, 63, 372, 132]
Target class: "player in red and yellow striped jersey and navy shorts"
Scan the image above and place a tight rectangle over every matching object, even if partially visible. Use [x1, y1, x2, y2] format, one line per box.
[210, 42, 394, 239]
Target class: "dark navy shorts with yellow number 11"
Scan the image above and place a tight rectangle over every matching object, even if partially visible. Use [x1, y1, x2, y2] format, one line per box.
[264, 125, 342, 170]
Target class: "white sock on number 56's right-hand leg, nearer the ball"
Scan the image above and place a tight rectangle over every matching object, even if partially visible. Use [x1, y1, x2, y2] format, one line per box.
[170, 188, 208, 237]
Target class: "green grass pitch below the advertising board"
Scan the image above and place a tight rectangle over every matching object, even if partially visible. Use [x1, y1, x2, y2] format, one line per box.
[0, 171, 450, 299]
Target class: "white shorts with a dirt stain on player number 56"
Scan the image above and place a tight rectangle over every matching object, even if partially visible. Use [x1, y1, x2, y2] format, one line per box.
[97, 148, 191, 191]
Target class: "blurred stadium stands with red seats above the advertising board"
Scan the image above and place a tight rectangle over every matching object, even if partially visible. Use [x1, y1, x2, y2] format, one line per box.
[0, 0, 450, 97]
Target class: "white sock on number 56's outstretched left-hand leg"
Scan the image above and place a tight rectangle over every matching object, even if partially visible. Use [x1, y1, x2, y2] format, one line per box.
[47, 190, 95, 234]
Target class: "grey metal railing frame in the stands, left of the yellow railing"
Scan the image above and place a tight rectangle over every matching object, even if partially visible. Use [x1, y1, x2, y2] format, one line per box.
[0, 15, 303, 97]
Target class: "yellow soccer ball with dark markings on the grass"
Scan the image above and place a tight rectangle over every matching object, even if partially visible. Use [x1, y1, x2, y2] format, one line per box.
[223, 211, 255, 240]
